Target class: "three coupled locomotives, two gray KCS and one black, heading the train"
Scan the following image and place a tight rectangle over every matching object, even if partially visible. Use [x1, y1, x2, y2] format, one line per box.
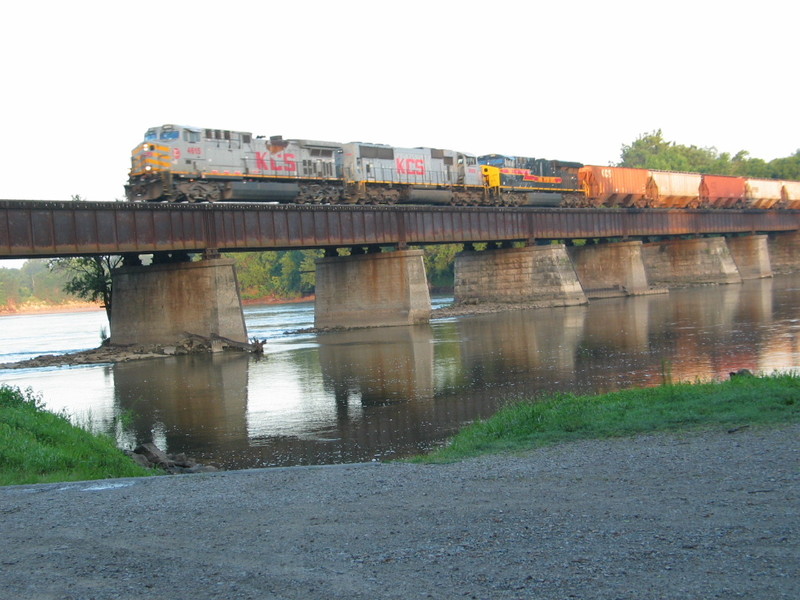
[125, 125, 581, 206]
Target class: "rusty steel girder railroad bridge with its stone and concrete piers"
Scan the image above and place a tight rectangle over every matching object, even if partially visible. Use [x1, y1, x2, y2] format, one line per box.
[0, 200, 800, 344]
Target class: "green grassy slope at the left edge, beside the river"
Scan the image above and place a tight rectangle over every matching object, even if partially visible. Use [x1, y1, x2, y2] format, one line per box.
[0, 385, 152, 485]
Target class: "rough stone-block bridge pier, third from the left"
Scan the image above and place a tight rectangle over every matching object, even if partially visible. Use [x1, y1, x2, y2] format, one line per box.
[454, 244, 587, 306]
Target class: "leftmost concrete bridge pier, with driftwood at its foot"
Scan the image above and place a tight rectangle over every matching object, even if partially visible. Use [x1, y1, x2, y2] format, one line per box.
[111, 259, 247, 345]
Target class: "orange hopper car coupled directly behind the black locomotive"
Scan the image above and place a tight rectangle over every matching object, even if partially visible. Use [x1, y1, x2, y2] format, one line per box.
[578, 165, 650, 206]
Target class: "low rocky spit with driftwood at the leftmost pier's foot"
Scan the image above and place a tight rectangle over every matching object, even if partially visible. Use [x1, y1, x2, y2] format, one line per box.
[0, 333, 265, 369]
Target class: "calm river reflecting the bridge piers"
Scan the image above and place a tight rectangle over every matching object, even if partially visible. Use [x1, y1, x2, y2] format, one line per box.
[0, 275, 800, 469]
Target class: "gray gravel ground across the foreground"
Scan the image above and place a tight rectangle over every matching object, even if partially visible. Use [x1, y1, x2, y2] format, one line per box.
[0, 425, 800, 600]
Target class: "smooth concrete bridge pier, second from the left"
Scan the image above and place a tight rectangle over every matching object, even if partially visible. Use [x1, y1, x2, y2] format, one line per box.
[314, 250, 431, 328]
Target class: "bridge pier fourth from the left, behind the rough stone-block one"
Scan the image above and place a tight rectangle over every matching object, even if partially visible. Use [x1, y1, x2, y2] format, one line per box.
[567, 241, 650, 298]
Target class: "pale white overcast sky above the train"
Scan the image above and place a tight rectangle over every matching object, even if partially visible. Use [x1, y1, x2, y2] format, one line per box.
[0, 0, 800, 268]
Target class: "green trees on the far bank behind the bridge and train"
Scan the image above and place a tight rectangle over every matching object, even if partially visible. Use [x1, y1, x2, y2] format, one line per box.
[0, 129, 800, 310]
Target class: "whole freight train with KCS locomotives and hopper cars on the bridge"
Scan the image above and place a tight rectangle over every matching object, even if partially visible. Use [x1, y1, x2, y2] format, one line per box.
[125, 125, 800, 209]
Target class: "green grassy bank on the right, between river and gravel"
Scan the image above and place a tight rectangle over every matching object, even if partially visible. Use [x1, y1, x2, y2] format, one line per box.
[415, 374, 800, 462]
